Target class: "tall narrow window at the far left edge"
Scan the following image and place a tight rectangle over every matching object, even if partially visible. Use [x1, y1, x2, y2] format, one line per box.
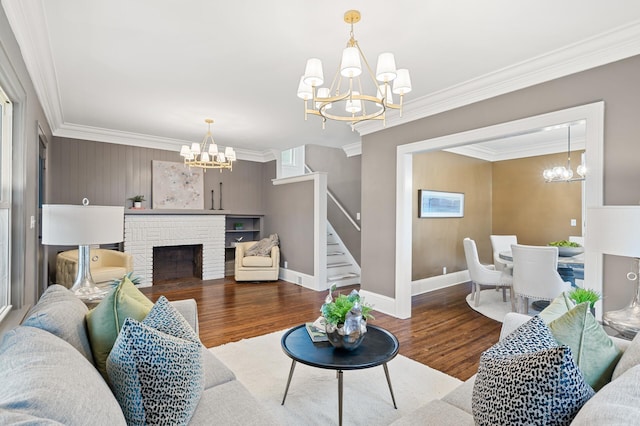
[0, 88, 12, 321]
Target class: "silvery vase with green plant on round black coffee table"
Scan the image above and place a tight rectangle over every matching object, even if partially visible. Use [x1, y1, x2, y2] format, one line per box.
[320, 284, 373, 351]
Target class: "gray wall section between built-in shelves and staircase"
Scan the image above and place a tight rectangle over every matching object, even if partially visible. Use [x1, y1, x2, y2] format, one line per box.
[262, 161, 314, 275]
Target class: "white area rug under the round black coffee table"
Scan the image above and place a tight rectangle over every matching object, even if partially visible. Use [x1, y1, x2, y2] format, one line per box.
[210, 330, 461, 425]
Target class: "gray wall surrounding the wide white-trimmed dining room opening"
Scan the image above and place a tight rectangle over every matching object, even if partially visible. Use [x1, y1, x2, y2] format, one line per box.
[362, 56, 640, 310]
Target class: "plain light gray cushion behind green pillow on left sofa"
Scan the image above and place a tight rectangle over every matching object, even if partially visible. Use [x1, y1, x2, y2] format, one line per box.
[22, 284, 93, 364]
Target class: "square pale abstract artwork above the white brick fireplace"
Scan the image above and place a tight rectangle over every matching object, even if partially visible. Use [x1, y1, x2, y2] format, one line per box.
[151, 160, 204, 210]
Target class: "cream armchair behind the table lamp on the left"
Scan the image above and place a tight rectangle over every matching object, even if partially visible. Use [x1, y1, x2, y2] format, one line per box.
[56, 248, 133, 288]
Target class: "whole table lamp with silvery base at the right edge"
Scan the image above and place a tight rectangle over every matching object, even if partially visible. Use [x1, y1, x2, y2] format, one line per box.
[587, 206, 640, 338]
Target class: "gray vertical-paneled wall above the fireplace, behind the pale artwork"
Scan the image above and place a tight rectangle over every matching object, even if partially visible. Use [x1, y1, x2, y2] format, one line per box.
[48, 137, 263, 214]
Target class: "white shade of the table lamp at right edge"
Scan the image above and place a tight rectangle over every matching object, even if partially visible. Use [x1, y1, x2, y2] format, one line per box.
[586, 206, 640, 257]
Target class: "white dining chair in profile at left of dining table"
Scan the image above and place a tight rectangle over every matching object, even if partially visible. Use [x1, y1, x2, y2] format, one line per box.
[462, 238, 515, 310]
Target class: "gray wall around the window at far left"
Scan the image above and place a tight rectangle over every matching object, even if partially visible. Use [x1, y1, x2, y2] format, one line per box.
[0, 4, 51, 329]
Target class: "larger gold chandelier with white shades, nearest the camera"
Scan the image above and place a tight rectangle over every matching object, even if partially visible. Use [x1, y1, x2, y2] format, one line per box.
[298, 10, 411, 130]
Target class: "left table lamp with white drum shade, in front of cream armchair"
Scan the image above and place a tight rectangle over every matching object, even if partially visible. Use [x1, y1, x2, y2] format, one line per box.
[42, 198, 124, 301]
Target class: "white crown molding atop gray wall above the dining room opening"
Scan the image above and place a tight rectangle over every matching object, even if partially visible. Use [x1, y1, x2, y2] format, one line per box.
[356, 21, 640, 136]
